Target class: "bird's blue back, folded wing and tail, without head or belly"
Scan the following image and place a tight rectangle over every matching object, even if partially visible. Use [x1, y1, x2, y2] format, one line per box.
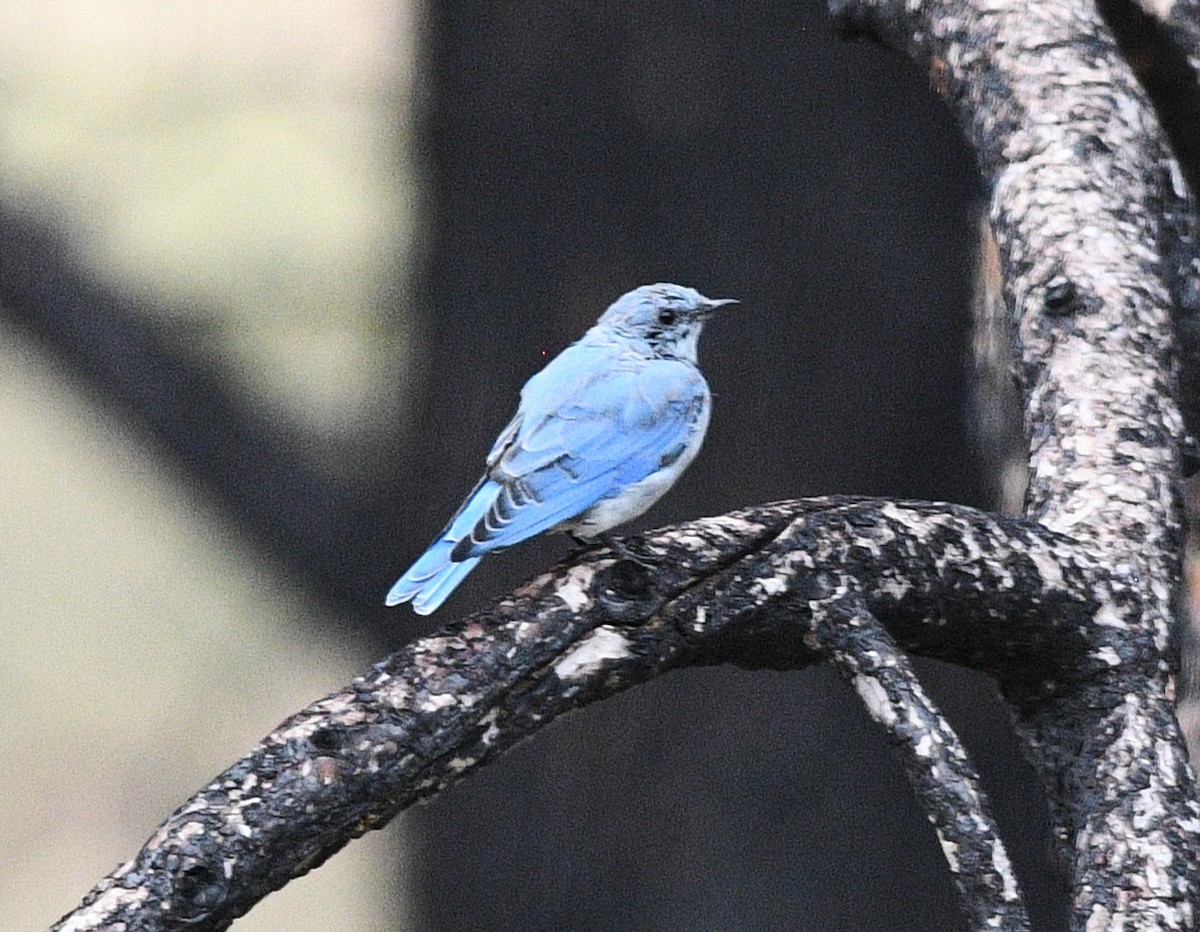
[386, 343, 708, 614]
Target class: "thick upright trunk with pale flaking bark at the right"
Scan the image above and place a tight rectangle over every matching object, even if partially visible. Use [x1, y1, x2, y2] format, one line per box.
[833, 0, 1198, 928]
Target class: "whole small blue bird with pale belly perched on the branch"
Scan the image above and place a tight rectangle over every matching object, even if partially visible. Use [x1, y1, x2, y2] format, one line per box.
[386, 283, 737, 615]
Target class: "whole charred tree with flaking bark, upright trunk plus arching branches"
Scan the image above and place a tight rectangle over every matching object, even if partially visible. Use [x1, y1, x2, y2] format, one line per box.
[60, 0, 1200, 930]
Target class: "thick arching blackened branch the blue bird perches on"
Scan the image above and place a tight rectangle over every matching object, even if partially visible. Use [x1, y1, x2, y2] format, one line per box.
[59, 499, 1132, 930]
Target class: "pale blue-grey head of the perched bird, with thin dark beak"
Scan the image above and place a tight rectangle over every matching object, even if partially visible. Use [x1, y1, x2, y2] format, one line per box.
[596, 282, 737, 362]
